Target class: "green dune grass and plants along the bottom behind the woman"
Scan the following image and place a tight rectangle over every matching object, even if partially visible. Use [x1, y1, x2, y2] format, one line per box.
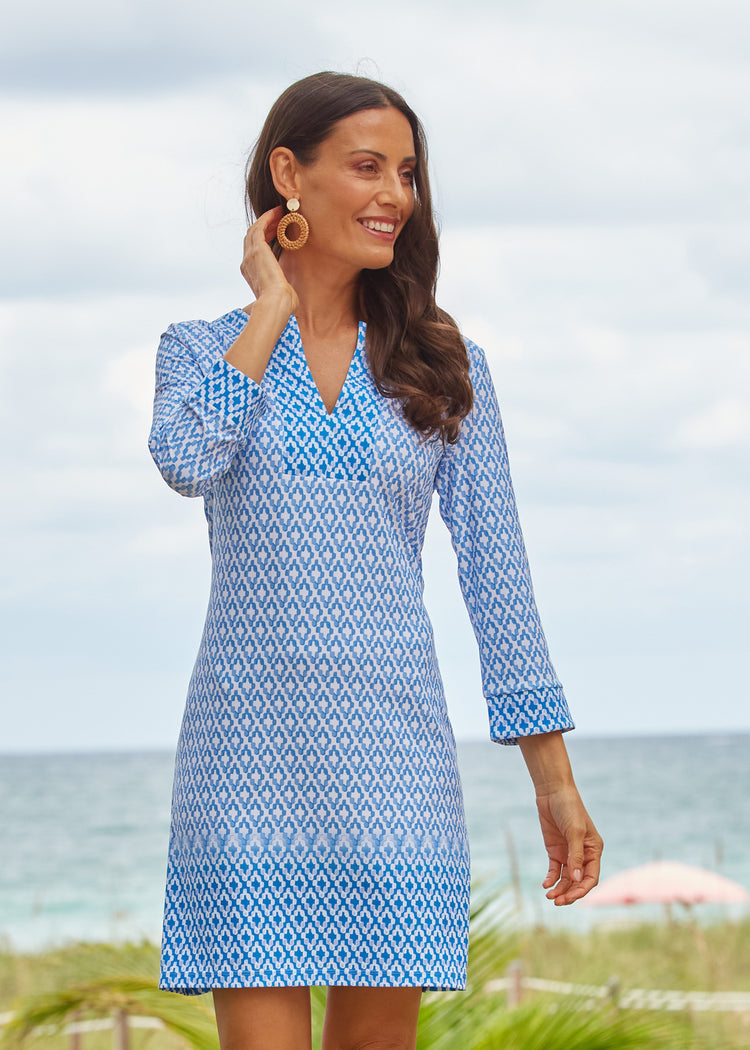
[0, 891, 750, 1050]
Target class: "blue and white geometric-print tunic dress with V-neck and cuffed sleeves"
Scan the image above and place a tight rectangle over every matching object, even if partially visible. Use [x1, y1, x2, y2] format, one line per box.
[149, 310, 572, 994]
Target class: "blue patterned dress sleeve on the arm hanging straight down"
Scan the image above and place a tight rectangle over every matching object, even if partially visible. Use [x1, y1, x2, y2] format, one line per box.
[436, 341, 574, 743]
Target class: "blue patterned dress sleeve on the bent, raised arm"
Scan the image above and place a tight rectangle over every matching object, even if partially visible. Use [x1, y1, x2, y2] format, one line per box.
[148, 321, 265, 496]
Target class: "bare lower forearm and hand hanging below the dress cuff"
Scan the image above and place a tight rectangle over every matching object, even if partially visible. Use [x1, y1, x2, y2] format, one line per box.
[518, 732, 603, 905]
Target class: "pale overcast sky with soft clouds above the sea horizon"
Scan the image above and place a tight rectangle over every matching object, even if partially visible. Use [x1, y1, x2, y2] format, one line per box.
[0, 0, 750, 752]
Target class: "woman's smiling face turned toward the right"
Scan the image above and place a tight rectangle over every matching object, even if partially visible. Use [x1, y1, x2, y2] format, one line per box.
[289, 106, 416, 271]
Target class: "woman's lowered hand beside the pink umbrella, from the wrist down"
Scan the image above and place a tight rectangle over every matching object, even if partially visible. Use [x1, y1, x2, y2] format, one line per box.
[537, 784, 603, 905]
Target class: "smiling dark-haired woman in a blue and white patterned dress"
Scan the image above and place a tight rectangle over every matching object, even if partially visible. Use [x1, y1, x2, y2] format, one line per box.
[149, 72, 601, 1050]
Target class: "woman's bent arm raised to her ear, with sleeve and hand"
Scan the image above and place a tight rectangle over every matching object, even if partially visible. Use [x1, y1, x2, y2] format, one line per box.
[148, 208, 297, 497]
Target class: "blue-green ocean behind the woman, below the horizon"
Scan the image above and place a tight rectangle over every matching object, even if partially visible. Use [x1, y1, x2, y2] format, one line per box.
[0, 733, 750, 950]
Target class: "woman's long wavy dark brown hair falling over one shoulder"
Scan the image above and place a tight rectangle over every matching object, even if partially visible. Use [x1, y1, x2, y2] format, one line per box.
[246, 72, 473, 444]
